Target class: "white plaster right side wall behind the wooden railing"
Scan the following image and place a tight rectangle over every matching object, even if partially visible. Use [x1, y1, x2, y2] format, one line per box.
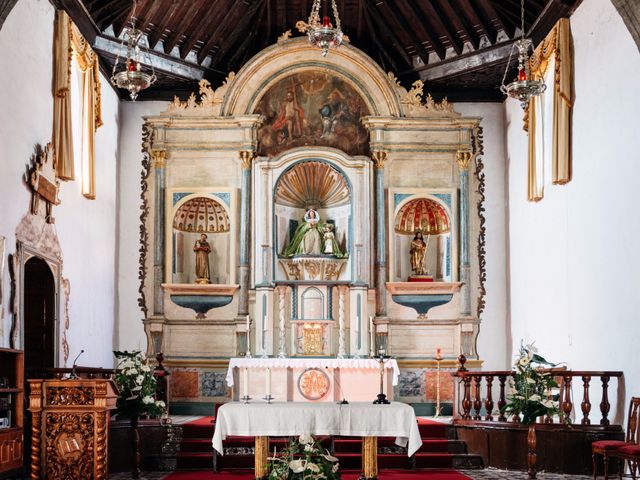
[506, 0, 640, 420]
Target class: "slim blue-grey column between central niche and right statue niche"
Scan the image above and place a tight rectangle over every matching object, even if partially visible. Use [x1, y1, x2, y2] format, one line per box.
[371, 150, 387, 317]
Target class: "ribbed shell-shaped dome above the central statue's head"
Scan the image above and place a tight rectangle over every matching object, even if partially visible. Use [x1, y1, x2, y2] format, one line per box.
[275, 160, 349, 209]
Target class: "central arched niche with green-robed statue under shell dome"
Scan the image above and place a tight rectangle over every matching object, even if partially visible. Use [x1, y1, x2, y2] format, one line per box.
[274, 160, 351, 281]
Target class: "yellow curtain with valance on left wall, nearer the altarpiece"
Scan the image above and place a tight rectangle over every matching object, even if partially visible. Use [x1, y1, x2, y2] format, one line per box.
[70, 23, 102, 199]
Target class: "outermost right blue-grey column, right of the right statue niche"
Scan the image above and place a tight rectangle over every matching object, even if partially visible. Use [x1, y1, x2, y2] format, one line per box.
[456, 150, 473, 317]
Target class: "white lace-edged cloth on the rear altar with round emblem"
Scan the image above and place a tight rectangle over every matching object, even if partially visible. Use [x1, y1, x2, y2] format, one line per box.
[225, 358, 400, 387]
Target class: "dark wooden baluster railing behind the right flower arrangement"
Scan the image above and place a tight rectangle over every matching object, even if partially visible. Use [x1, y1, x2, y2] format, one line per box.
[452, 365, 622, 425]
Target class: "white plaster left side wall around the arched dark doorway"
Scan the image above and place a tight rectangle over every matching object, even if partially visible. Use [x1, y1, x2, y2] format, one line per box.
[0, 0, 118, 367]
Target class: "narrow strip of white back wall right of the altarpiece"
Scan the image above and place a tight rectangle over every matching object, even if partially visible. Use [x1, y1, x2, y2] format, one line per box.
[455, 103, 509, 370]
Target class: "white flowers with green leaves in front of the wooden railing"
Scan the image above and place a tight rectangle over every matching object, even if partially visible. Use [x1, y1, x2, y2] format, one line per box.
[502, 343, 559, 425]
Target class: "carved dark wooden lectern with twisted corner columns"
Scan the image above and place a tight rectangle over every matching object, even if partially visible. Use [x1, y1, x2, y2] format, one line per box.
[29, 378, 118, 480]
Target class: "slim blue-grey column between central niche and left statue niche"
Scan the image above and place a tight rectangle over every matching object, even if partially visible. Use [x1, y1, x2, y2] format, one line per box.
[238, 150, 255, 317]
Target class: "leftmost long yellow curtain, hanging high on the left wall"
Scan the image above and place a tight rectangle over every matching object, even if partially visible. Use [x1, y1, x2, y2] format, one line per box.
[53, 10, 75, 180]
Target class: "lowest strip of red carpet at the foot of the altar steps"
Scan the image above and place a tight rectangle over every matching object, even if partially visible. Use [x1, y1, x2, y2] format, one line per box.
[165, 470, 471, 480]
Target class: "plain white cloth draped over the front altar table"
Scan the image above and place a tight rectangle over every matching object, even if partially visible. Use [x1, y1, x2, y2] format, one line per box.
[212, 402, 422, 456]
